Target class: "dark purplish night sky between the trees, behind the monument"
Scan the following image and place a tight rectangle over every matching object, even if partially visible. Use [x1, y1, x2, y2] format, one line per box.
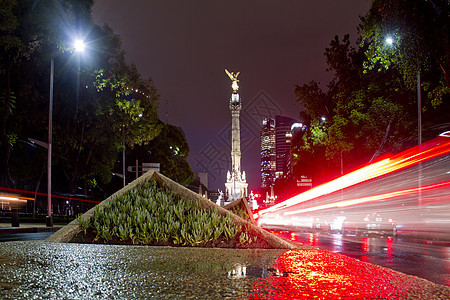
[93, 0, 371, 191]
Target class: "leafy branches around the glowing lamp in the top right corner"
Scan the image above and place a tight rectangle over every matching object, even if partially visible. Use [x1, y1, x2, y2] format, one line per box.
[361, 0, 450, 107]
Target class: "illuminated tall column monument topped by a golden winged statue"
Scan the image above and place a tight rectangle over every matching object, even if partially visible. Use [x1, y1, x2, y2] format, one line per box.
[225, 69, 248, 202]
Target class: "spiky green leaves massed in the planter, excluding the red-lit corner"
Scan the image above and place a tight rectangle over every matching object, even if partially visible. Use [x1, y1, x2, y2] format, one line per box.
[80, 180, 248, 246]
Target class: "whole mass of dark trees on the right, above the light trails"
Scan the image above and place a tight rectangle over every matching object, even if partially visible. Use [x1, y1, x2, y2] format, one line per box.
[291, 0, 450, 183]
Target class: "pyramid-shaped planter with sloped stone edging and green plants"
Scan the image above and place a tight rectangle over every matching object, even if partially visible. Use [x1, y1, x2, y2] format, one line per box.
[47, 171, 306, 249]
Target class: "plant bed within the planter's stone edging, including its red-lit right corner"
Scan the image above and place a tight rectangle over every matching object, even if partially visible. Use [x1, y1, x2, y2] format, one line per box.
[71, 178, 271, 248]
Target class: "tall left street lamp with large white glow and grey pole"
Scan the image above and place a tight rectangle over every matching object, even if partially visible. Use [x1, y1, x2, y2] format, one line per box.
[45, 40, 85, 227]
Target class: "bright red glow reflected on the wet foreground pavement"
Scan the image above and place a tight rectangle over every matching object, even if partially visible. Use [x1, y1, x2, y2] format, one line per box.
[249, 250, 446, 299]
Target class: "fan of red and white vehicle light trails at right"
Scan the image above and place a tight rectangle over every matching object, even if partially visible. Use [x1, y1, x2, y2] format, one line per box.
[258, 136, 450, 240]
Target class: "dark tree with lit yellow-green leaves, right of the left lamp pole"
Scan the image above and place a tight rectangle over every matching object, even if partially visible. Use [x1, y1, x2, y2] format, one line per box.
[56, 27, 161, 191]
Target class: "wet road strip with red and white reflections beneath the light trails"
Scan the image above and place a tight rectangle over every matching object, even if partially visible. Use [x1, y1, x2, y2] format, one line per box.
[281, 232, 450, 286]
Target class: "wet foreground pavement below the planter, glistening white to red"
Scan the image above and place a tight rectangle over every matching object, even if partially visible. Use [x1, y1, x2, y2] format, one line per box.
[0, 241, 450, 299]
